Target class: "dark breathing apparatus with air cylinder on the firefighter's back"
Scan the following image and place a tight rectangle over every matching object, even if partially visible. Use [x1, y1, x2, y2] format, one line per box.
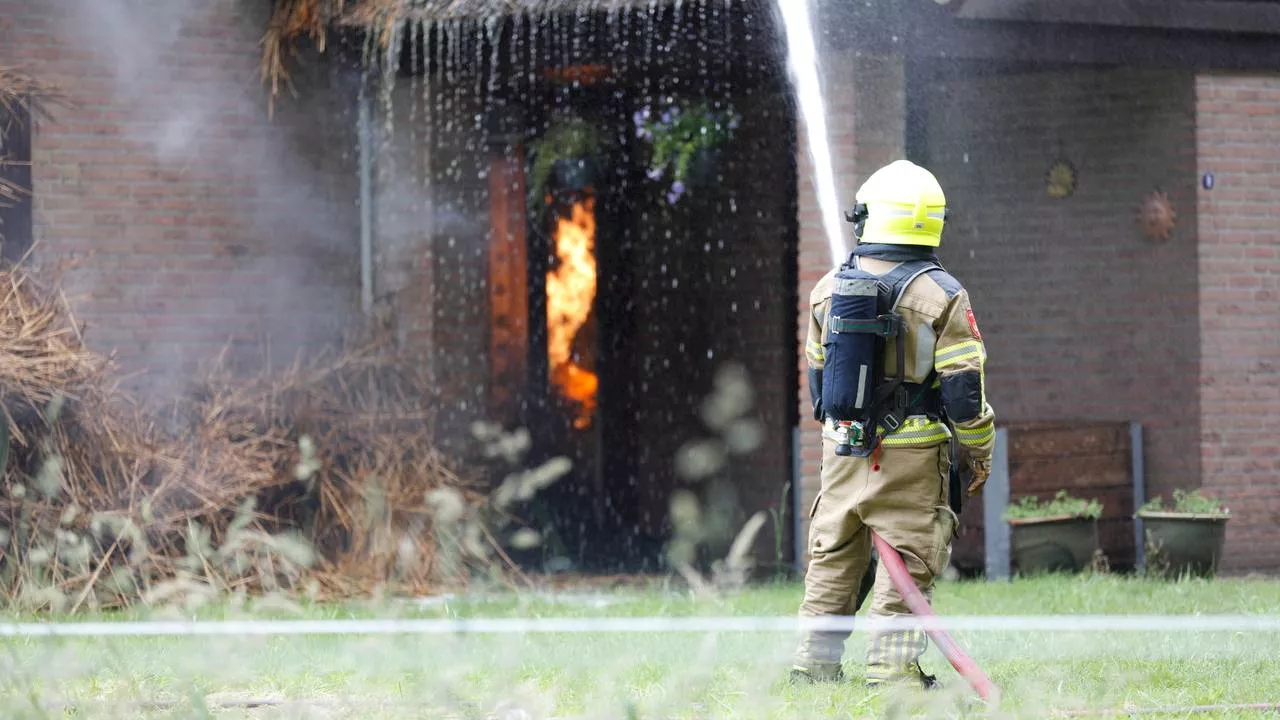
[822, 256, 943, 457]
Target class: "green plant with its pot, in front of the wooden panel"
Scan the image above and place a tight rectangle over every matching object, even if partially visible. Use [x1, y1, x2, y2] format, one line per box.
[1005, 489, 1102, 575]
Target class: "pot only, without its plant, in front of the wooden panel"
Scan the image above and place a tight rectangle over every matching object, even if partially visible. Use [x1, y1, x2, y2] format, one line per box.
[1009, 515, 1098, 575]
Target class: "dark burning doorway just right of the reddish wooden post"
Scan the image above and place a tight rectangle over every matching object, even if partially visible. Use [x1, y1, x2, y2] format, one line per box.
[507, 109, 650, 570]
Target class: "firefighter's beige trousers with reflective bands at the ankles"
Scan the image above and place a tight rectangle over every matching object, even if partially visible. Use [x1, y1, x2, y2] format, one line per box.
[796, 430, 957, 680]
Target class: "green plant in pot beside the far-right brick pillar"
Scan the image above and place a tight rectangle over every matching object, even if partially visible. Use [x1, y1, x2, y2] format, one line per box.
[1138, 489, 1231, 578]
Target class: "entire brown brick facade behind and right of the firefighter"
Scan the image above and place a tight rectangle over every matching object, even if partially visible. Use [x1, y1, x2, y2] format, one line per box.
[797, 56, 1280, 570]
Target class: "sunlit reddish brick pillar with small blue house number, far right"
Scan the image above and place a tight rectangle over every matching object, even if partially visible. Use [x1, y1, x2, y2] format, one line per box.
[1196, 74, 1280, 571]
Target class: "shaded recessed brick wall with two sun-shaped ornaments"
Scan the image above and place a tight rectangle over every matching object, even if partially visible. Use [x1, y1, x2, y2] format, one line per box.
[922, 68, 1201, 507]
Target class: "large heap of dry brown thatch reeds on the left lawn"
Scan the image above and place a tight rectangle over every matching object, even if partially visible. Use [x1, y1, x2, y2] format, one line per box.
[0, 260, 500, 611]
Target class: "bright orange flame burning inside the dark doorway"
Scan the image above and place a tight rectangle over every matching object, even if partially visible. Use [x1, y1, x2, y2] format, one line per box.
[547, 197, 599, 429]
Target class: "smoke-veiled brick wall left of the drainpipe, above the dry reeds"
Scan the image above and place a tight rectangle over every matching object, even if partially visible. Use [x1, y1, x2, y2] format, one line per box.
[0, 0, 358, 395]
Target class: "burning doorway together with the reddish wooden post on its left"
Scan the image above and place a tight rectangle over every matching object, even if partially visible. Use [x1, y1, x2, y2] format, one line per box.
[488, 92, 640, 570]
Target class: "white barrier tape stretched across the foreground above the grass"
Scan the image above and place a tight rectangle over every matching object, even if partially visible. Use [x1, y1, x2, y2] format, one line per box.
[0, 615, 1280, 638]
